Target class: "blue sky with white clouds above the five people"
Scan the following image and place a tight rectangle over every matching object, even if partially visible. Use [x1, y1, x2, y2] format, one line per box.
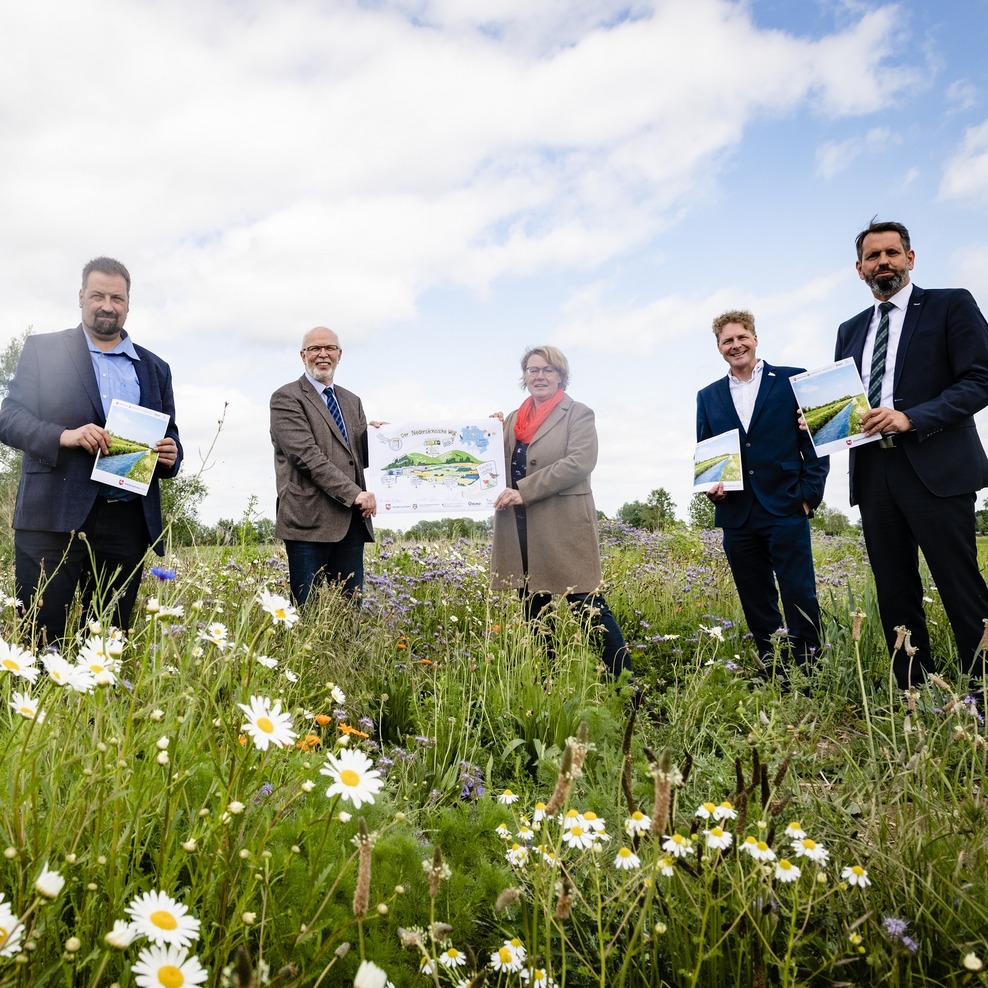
[0, 0, 988, 522]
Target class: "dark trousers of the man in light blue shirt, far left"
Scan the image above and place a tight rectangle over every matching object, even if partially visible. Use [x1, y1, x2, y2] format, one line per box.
[14, 497, 150, 644]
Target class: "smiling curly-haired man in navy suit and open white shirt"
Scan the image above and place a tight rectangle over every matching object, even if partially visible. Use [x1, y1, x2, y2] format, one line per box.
[696, 311, 830, 663]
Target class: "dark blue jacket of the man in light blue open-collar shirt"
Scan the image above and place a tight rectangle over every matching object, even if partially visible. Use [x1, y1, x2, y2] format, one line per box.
[0, 324, 182, 555]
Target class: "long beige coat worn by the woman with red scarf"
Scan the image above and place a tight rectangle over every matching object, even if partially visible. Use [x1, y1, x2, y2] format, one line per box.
[491, 395, 601, 594]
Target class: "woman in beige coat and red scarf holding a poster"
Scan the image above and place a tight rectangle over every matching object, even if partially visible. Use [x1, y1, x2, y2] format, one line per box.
[491, 346, 631, 677]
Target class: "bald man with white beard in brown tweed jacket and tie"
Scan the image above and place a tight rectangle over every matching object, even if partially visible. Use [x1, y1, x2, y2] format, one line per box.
[271, 326, 377, 607]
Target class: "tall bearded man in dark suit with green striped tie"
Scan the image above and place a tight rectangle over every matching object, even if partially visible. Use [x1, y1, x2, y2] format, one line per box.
[836, 221, 988, 688]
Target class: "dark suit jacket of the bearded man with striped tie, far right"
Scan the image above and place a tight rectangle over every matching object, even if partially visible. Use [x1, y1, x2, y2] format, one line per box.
[835, 285, 988, 504]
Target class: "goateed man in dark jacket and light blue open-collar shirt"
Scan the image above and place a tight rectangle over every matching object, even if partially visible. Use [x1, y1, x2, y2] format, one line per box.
[0, 257, 182, 644]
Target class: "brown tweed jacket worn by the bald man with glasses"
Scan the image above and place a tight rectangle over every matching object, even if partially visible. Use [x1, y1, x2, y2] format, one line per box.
[271, 374, 374, 542]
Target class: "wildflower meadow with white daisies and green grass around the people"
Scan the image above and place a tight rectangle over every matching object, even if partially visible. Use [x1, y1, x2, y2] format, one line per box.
[0, 523, 988, 988]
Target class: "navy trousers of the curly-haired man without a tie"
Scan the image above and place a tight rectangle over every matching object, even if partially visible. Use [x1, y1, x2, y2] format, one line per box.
[724, 501, 820, 663]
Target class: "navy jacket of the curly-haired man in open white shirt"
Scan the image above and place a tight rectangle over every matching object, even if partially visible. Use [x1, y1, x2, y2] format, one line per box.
[696, 361, 830, 528]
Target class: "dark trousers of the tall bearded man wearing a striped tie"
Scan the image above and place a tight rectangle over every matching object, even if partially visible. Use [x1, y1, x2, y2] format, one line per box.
[855, 443, 988, 688]
